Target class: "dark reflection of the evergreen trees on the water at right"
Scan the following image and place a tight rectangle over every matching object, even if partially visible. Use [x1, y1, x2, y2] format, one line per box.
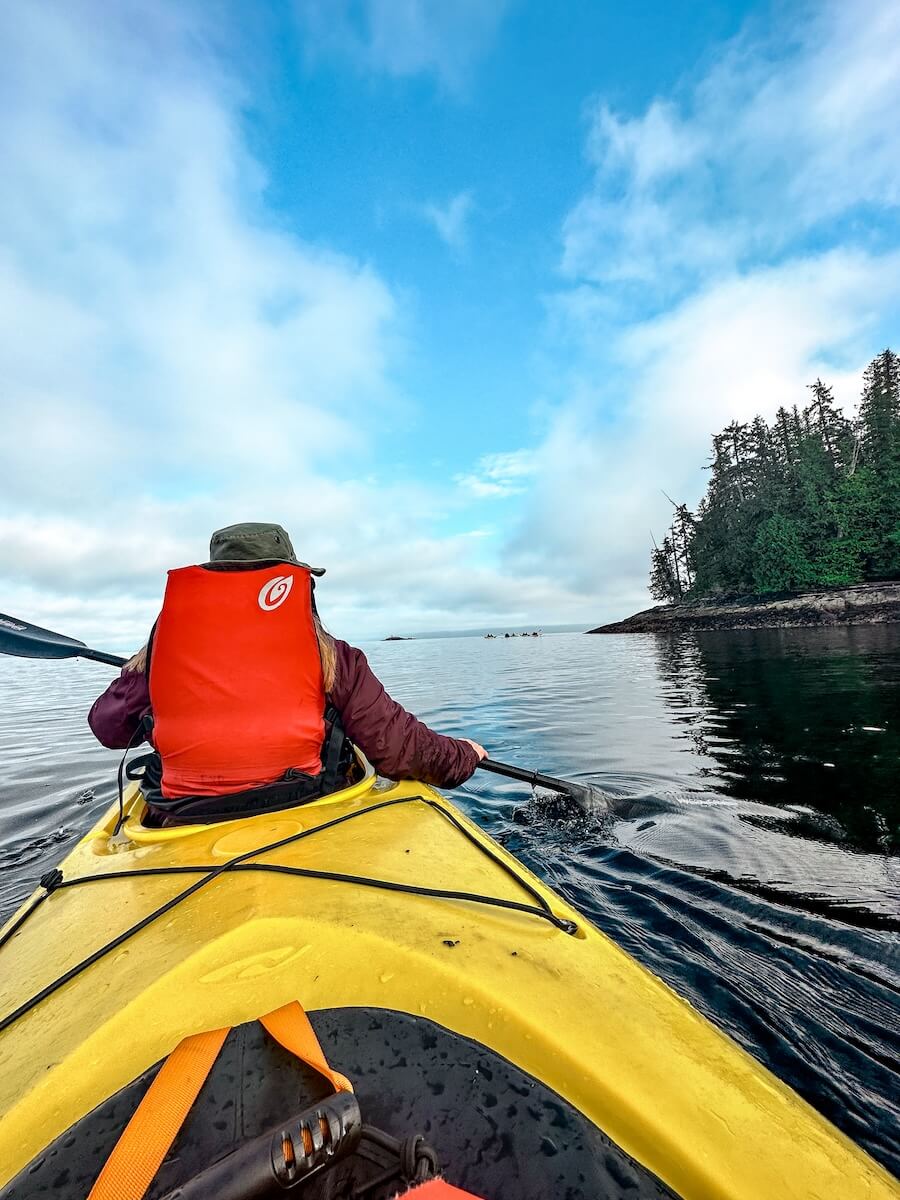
[656, 625, 900, 853]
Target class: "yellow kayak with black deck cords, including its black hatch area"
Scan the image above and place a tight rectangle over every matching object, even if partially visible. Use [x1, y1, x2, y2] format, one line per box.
[0, 768, 899, 1200]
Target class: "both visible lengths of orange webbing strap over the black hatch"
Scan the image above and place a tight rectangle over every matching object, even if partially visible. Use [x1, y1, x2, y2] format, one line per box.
[88, 1001, 353, 1200]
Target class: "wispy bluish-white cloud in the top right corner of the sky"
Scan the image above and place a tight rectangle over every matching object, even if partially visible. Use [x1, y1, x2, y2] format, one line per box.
[564, 0, 900, 290]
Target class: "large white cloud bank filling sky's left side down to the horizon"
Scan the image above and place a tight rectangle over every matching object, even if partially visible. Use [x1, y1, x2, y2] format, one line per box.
[0, 2, 552, 649]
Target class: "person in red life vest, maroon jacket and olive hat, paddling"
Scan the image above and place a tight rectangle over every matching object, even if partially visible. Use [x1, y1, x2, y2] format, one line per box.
[88, 522, 486, 821]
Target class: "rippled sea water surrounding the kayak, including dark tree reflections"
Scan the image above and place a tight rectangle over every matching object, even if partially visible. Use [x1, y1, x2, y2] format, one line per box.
[0, 626, 900, 1174]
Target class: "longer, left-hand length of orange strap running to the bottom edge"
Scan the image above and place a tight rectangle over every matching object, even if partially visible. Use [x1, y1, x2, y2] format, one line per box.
[88, 1030, 228, 1200]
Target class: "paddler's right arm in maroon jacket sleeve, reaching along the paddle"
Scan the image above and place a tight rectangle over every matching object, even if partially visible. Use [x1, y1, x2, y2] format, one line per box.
[331, 640, 485, 787]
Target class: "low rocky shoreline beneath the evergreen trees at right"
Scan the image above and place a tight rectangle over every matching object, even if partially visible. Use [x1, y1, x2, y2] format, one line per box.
[588, 581, 900, 634]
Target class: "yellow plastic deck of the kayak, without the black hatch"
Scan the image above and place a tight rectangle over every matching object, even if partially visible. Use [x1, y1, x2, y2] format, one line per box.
[0, 773, 896, 1200]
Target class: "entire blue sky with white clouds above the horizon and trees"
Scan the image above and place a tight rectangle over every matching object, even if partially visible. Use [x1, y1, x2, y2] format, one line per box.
[0, 0, 900, 647]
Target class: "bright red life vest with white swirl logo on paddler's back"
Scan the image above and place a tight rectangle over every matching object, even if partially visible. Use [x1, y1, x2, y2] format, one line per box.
[150, 563, 325, 799]
